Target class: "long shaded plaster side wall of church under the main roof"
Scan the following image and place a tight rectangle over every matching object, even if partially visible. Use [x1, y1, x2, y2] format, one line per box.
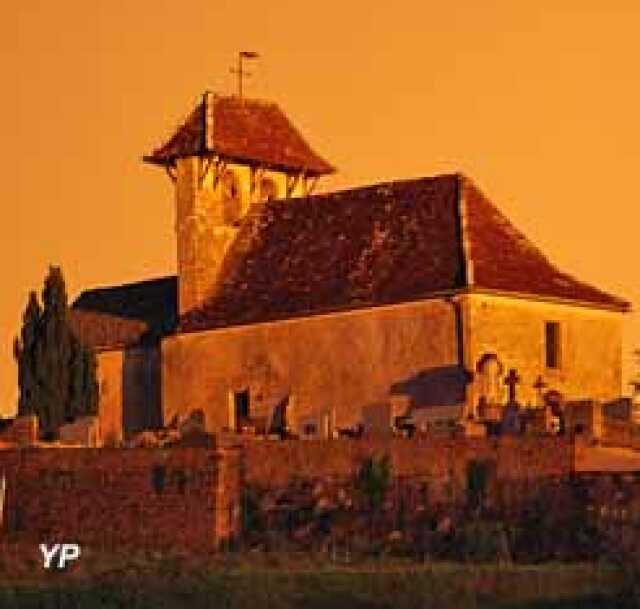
[162, 299, 464, 432]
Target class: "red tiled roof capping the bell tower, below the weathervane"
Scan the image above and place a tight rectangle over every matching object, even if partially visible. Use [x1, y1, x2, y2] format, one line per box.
[144, 94, 335, 175]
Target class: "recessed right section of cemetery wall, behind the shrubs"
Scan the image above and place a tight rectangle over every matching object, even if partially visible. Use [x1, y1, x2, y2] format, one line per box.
[232, 437, 573, 523]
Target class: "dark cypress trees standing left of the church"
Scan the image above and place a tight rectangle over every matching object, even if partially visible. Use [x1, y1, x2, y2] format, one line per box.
[14, 267, 98, 437]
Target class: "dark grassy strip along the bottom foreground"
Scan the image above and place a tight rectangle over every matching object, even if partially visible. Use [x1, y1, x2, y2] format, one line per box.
[0, 556, 640, 609]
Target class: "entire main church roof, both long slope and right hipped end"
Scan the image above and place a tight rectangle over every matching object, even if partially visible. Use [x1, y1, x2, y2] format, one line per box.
[180, 175, 628, 331]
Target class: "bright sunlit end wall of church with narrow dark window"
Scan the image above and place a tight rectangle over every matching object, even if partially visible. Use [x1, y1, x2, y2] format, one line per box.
[463, 294, 623, 406]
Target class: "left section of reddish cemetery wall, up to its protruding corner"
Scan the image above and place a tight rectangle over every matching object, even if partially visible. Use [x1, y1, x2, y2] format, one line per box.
[0, 448, 240, 552]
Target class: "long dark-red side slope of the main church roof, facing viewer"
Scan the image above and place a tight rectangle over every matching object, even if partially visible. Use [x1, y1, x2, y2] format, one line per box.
[181, 176, 463, 329]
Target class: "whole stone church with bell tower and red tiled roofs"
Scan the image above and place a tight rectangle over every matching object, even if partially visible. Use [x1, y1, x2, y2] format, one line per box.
[67, 93, 629, 443]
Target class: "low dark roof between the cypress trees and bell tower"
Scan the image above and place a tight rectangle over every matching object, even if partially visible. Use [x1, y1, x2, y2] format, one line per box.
[71, 276, 178, 348]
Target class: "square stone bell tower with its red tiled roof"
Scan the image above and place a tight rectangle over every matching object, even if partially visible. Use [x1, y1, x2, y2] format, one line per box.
[144, 92, 335, 315]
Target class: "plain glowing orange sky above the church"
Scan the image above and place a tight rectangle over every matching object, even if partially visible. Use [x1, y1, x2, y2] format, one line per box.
[0, 0, 640, 412]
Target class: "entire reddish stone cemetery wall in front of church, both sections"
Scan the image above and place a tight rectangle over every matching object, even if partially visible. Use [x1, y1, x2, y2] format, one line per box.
[0, 436, 573, 552]
